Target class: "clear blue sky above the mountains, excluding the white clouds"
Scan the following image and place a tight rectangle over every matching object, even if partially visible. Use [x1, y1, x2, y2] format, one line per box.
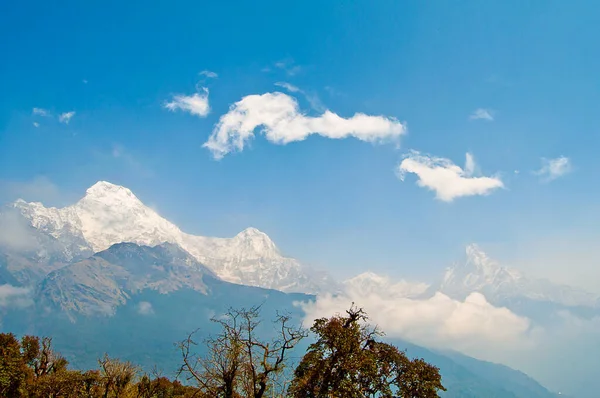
[0, 1, 600, 290]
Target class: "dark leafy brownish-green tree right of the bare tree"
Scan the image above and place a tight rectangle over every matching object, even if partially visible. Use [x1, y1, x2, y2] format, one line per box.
[288, 305, 445, 398]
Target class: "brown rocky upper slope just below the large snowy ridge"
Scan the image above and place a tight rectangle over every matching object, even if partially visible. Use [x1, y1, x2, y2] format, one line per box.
[35, 243, 216, 318]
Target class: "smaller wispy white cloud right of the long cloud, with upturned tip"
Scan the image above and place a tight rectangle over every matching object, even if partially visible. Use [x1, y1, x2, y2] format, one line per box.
[398, 151, 504, 202]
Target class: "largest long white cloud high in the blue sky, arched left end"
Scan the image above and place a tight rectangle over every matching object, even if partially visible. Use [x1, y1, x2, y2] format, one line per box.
[203, 92, 406, 159]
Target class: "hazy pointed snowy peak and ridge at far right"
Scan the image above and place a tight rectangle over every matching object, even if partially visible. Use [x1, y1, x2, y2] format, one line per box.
[437, 244, 598, 307]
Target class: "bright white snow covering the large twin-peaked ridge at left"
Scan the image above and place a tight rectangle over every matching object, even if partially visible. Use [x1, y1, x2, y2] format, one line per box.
[7, 181, 330, 293]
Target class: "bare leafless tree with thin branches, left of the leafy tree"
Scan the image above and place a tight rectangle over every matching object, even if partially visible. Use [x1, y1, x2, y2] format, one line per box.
[179, 306, 307, 398]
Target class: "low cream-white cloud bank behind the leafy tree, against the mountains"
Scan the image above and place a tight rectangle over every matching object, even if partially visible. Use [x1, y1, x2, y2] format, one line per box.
[299, 276, 531, 353]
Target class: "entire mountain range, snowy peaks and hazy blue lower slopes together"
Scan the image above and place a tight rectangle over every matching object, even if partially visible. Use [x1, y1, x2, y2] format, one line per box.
[0, 182, 598, 398]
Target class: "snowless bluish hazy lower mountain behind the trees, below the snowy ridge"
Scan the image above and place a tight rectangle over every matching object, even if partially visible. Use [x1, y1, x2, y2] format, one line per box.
[0, 243, 554, 398]
